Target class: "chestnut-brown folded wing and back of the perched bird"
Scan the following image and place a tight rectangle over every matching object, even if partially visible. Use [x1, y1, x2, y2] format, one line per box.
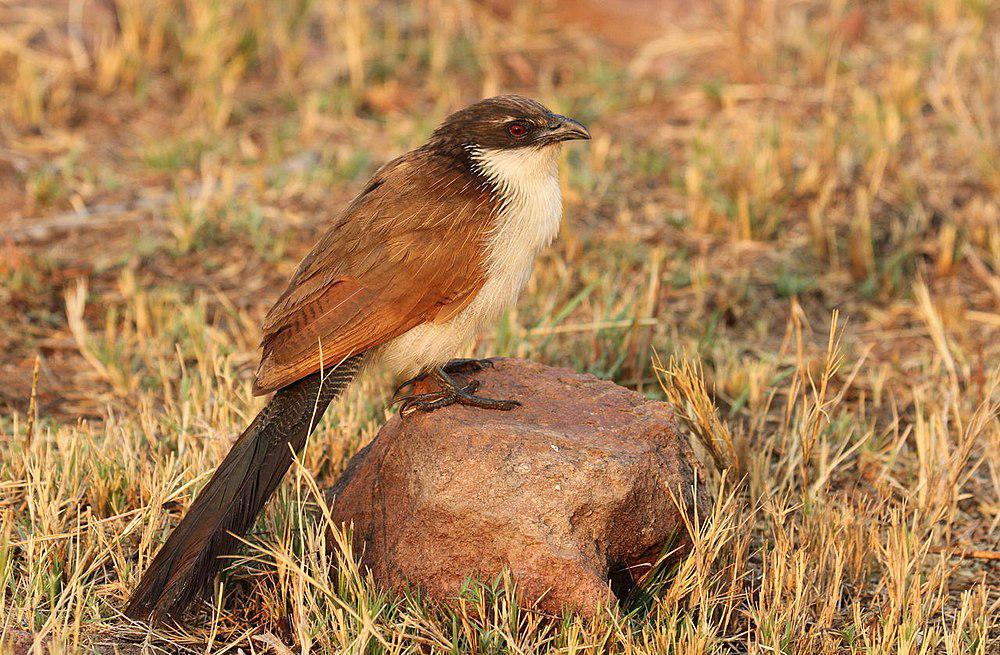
[254, 151, 492, 395]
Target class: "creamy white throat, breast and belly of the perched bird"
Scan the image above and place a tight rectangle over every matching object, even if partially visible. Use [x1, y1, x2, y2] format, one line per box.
[379, 145, 562, 376]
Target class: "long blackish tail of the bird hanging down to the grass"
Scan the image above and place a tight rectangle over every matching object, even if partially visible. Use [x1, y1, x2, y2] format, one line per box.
[125, 355, 361, 620]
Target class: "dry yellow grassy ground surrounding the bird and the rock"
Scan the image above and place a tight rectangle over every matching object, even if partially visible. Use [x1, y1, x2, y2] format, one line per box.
[0, 0, 1000, 655]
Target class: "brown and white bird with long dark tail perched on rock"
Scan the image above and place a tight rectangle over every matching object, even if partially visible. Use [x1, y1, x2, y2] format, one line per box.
[124, 95, 590, 622]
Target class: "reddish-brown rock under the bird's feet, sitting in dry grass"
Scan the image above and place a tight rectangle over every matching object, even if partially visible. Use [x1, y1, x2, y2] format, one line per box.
[330, 359, 704, 614]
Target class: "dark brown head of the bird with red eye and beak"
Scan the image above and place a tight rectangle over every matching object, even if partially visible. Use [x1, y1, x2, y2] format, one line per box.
[431, 95, 590, 150]
